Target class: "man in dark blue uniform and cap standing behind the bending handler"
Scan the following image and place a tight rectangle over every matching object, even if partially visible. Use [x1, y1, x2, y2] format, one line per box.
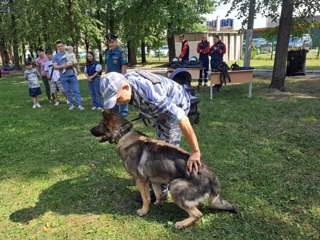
[105, 33, 128, 117]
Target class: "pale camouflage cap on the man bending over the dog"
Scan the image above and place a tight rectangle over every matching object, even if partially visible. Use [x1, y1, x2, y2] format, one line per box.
[100, 72, 126, 109]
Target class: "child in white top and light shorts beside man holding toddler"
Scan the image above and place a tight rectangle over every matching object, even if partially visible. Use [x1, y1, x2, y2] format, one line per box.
[44, 49, 69, 106]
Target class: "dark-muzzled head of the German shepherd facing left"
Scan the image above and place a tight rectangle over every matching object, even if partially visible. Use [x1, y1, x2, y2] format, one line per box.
[90, 110, 132, 143]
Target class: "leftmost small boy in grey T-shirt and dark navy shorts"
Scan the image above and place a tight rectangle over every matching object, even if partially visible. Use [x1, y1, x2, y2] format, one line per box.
[24, 61, 41, 108]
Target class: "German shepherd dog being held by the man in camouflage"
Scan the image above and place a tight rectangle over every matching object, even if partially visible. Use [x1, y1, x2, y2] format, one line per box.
[91, 111, 236, 229]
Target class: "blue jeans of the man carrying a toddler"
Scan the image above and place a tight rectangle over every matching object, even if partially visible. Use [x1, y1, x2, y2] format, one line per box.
[60, 75, 81, 106]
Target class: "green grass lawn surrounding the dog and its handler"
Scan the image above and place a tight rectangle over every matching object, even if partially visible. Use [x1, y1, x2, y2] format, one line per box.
[0, 70, 320, 240]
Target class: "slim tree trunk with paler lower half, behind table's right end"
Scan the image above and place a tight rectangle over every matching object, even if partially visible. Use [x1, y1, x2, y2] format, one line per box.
[243, 0, 256, 67]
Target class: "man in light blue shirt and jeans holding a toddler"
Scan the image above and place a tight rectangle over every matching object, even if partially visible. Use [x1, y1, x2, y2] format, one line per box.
[52, 41, 84, 111]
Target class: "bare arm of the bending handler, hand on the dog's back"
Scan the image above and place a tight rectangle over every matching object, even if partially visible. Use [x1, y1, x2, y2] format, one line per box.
[179, 116, 202, 173]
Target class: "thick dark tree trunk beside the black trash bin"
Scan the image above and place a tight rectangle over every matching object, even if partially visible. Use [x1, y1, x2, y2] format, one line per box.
[270, 0, 294, 92]
